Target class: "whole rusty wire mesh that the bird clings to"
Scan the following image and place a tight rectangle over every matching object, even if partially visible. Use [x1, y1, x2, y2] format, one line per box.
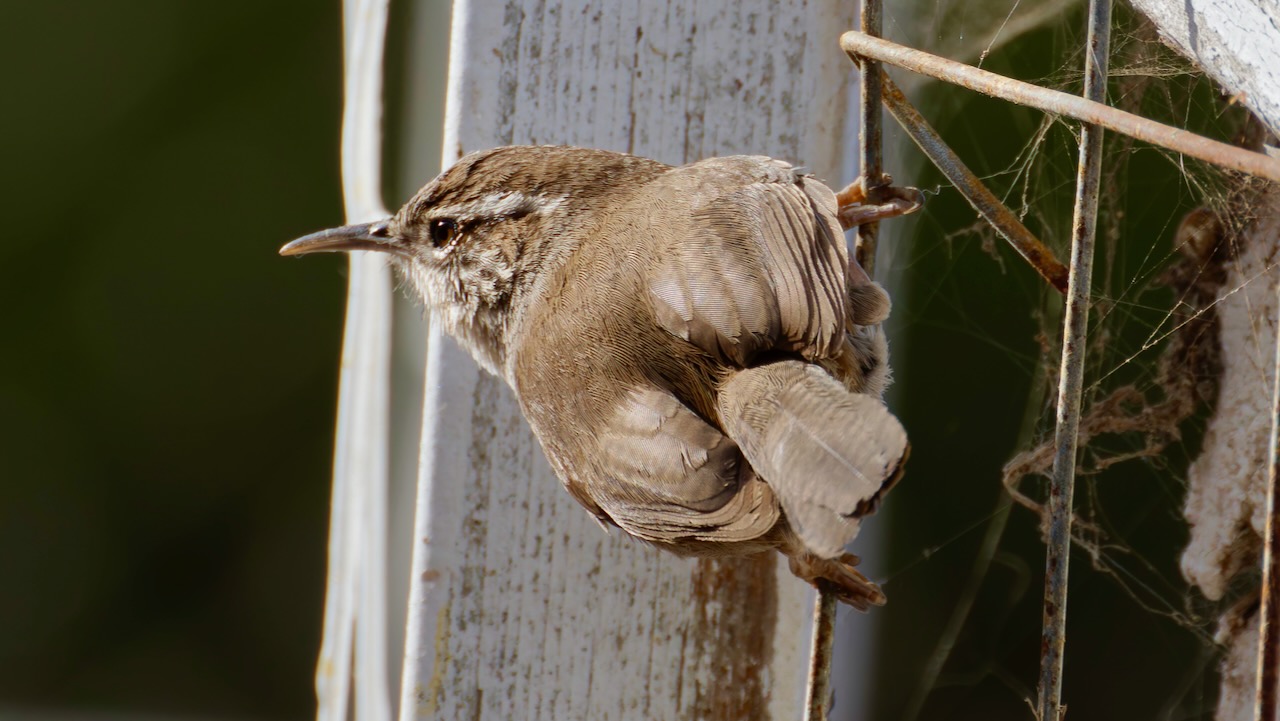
[834, 0, 1280, 721]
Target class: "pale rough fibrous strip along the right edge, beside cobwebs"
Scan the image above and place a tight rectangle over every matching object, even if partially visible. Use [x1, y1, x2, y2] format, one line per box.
[1181, 192, 1280, 601]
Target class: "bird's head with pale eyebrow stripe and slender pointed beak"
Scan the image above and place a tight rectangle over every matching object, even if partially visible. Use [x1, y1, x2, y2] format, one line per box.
[280, 146, 667, 374]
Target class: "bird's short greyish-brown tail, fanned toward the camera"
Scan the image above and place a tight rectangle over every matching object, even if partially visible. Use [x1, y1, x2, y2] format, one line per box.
[717, 360, 909, 558]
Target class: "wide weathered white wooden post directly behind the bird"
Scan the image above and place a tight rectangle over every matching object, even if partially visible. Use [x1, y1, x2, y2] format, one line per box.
[401, 0, 854, 720]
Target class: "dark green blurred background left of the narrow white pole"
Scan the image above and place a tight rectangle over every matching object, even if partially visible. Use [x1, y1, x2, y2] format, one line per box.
[0, 0, 344, 718]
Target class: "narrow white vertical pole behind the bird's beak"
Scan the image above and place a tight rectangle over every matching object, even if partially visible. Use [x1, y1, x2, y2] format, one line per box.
[316, 0, 392, 721]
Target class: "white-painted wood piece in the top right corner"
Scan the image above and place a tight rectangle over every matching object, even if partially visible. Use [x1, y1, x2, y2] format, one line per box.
[1133, 0, 1280, 133]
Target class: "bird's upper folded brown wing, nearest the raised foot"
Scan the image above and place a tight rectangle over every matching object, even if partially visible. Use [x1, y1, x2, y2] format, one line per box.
[648, 156, 849, 366]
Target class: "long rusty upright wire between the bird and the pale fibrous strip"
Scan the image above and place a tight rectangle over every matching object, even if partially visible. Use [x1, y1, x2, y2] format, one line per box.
[1038, 0, 1111, 721]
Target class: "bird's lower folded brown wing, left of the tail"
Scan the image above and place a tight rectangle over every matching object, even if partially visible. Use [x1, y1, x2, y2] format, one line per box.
[582, 388, 778, 544]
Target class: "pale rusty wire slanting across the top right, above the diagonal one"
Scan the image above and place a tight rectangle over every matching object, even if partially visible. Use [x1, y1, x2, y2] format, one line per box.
[840, 31, 1280, 182]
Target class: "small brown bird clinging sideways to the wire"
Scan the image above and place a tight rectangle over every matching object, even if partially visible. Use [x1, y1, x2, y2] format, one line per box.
[280, 146, 920, 610]
